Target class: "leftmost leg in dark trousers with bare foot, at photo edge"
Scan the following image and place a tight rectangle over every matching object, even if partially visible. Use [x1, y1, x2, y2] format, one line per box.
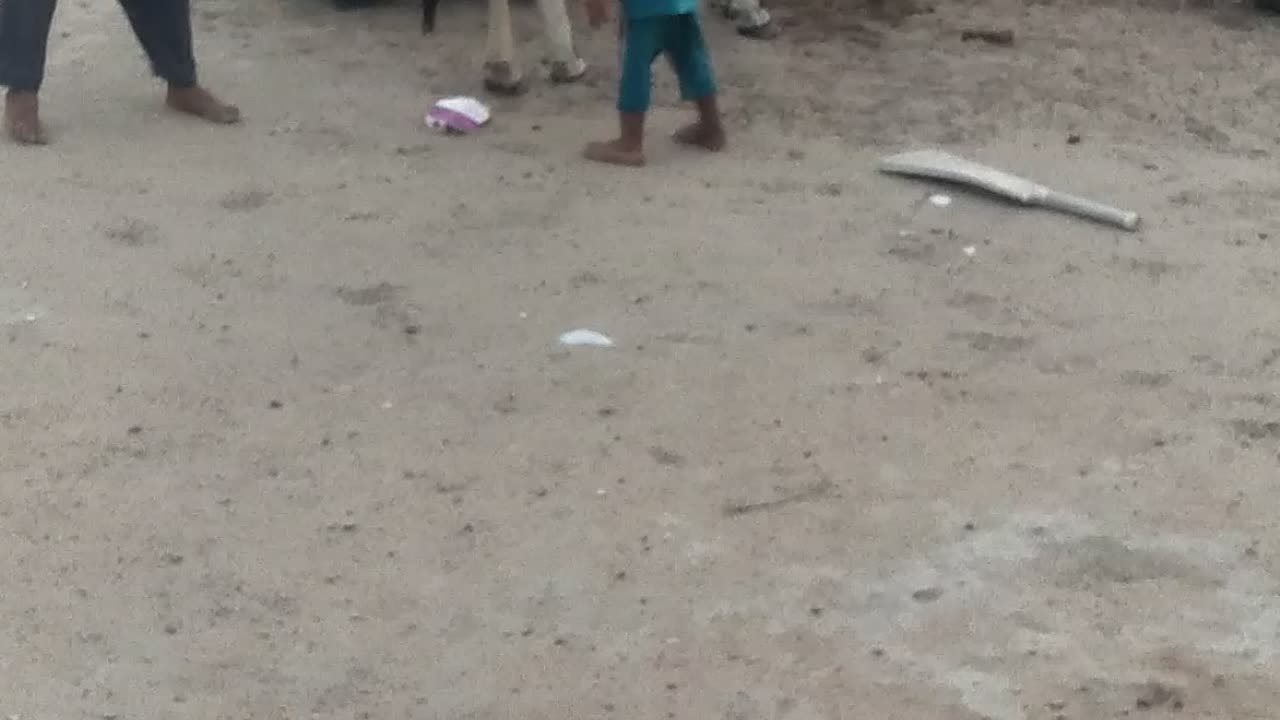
[0, 0, 56, 145]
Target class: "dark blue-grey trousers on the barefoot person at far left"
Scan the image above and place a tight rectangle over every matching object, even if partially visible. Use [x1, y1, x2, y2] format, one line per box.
[0, 0, 196, 92]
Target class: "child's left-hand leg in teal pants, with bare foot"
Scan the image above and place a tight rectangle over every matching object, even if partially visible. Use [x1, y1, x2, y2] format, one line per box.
[582, 18, 662, 165]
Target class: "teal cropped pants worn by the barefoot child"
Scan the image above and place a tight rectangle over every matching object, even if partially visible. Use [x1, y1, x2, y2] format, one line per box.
[618, 13, 716, 113]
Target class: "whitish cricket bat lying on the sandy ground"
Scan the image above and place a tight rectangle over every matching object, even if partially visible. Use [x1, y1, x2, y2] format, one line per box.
[881, 150, 1140, 231]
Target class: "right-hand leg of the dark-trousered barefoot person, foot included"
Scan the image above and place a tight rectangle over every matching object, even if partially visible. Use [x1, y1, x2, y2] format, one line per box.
[120, 0, 241, 124]
